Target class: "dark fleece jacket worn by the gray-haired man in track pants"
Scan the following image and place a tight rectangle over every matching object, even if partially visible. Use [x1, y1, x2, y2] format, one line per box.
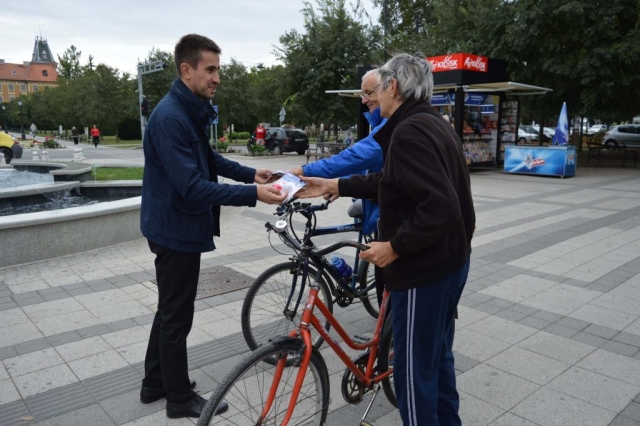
[339, 101, 476, 290]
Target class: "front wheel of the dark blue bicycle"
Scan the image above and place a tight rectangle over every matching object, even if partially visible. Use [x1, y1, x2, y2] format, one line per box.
[240, 262, 333, 350]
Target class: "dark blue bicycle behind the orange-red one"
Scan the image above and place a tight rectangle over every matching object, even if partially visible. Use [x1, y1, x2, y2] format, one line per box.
[241, 202, 378, 350]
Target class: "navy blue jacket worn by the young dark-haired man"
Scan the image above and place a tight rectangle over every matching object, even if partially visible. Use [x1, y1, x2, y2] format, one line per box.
[140, 79, 258, 253]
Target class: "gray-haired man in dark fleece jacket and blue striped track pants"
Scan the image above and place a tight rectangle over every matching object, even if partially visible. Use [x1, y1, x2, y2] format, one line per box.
[296, 54, 475, 426]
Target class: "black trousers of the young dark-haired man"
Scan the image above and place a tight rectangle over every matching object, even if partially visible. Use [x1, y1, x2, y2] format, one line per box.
[142, 241, 200, 403]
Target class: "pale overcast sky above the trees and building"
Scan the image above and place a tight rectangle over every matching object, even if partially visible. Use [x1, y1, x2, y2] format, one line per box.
[0, 0, 380, 74]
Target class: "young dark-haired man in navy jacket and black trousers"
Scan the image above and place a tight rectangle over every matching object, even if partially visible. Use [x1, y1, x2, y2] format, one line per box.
[140, 34, 285, 418]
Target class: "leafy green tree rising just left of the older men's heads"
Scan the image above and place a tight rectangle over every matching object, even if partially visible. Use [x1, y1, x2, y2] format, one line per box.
[275, 0, 382, 125]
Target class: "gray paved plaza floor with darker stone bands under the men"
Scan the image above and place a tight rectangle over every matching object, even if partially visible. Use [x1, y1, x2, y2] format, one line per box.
[0, 149, 640, 426]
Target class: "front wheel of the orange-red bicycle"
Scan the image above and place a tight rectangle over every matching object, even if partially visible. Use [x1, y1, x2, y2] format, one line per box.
[197, 339, 330, 426]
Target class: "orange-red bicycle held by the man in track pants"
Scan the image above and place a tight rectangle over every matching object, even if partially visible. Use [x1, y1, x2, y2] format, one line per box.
[197, 208, 398, 426]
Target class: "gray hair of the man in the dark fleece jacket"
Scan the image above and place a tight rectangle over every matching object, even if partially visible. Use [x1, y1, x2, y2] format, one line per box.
[377, 53, 433, 102]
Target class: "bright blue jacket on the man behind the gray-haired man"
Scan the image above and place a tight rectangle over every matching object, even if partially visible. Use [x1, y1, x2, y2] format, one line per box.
[302, 108, 387, 234]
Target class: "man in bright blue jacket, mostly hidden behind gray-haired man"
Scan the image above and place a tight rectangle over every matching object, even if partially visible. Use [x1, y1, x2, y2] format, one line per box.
[291, 70, 387, 303]
